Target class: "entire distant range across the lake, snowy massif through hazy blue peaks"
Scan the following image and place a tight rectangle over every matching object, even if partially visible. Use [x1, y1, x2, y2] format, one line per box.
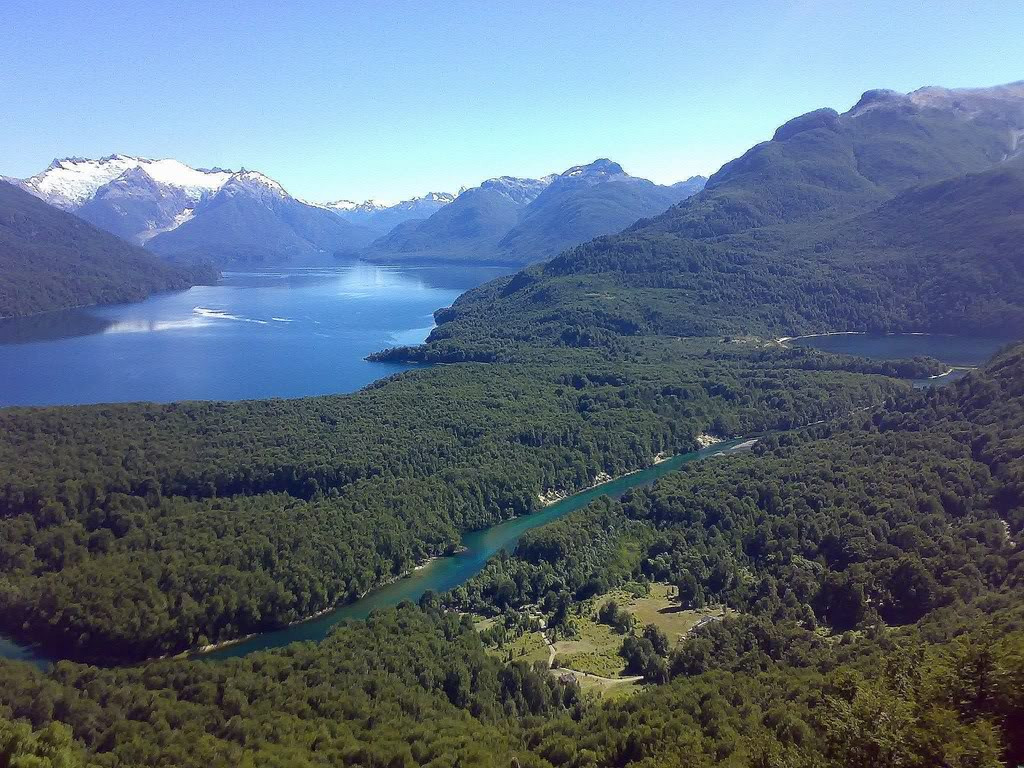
[7, 155, 705, 266]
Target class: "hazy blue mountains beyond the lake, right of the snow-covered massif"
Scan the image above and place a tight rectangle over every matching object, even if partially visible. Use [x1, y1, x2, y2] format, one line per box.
[362, 160, 706, 264]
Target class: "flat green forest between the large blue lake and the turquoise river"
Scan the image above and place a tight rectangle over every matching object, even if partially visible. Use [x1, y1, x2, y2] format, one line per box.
[0, 341, 909, 659]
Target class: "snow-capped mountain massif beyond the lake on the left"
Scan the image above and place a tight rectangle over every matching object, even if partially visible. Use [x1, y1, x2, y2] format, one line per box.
[12, 155, 380, 265]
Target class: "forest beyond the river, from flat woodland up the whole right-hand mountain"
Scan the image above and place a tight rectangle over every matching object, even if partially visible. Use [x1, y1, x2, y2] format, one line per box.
[0, 85, 1024, 659]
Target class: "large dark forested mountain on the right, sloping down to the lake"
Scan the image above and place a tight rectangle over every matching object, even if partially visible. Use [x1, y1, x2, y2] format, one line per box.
[401, 82, 1024, 360]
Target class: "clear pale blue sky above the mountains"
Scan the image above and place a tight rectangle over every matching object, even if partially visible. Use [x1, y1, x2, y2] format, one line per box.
[0, 0, 1024, 200]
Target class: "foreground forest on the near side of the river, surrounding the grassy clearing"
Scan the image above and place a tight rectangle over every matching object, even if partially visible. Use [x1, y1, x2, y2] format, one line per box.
[0, 346, 1024, 768]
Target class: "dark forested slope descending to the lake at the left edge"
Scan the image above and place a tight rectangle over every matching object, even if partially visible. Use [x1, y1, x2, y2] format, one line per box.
[0, 181, 217, 317]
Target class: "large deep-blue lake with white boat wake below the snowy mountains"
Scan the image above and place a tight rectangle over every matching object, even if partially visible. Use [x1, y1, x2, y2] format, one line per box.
[0, 263, 507, 406]
